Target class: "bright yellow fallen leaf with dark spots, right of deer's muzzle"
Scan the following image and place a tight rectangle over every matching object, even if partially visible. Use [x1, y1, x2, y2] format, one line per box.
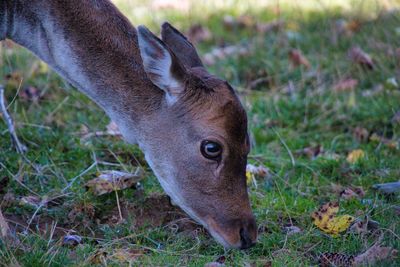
[311, 202, 354, 237]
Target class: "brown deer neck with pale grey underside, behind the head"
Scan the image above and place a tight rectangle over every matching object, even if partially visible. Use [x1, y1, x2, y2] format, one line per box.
[0, 0, 162, 144]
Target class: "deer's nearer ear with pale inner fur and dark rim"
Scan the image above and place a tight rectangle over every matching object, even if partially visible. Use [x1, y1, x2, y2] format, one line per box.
[138, 26, 186, 104]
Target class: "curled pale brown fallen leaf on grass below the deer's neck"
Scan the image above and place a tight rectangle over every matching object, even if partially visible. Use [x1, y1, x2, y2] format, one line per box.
[85, 171, 143, 196]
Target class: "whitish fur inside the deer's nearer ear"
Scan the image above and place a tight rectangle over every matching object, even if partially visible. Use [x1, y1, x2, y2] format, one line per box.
[138, 31, 183, 105]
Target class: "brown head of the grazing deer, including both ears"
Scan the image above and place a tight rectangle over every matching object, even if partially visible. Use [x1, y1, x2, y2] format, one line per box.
[136, 23, 257, 248]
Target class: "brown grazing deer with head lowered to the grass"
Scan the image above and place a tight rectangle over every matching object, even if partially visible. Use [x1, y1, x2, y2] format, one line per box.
[0, 0, 257, 249]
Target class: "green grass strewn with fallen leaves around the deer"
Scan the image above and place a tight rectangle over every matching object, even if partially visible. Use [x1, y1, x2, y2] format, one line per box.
[0, 0, 400, 266]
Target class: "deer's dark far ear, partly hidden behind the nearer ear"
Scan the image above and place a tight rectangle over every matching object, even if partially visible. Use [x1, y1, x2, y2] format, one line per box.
[161, 22, 203, 68]
